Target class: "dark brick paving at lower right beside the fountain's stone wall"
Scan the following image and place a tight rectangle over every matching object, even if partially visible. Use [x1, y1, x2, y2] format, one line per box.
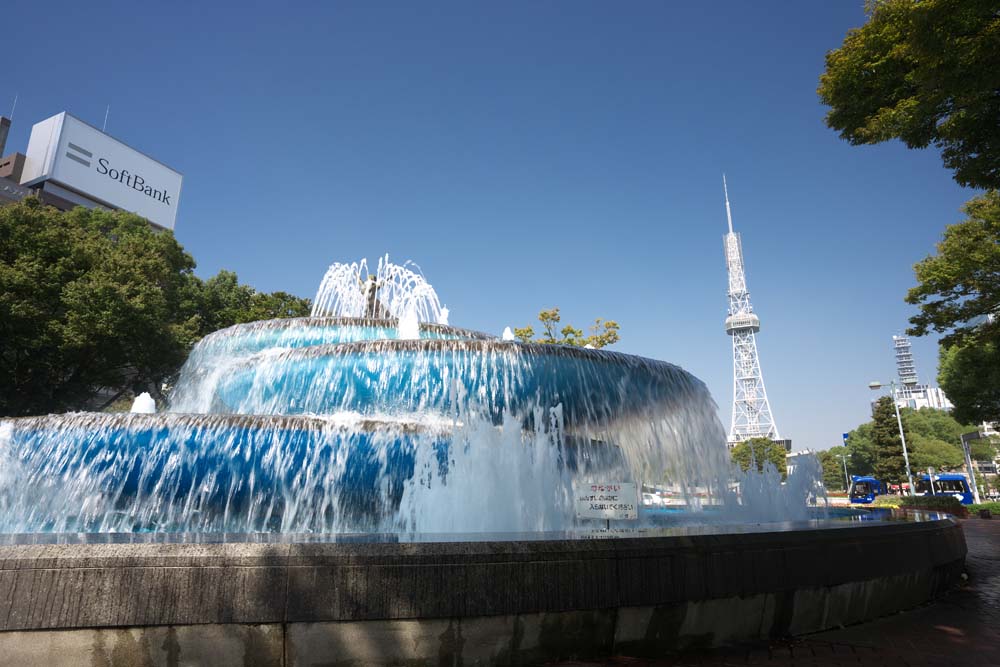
[564, 518, 1000, 667]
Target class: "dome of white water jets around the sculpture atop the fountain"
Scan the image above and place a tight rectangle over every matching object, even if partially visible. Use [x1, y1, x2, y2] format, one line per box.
[312, 255, 448, 324]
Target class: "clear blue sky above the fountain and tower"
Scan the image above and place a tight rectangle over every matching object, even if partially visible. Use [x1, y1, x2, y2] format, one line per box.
[0, 0, 975, 448]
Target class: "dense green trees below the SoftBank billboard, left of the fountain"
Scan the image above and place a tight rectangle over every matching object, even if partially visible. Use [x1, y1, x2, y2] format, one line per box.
[0, 197, 308, 416]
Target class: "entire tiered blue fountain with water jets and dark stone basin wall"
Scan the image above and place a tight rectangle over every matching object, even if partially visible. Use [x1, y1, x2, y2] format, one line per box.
[0, 257, 964, 664]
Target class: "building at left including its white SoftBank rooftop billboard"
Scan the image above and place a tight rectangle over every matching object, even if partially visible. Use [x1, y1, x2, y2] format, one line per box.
[0, 112, 184, 229]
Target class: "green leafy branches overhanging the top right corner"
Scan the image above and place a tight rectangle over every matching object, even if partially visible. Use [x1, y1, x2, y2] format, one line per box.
[817, 0, 1000, 188]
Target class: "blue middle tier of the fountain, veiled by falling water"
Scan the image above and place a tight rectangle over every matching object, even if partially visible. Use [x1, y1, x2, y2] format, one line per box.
[209, 339, 710, 426]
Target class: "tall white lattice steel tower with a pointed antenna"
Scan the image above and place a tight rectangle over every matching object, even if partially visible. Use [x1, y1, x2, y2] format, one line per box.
[722, 176, 781, 447]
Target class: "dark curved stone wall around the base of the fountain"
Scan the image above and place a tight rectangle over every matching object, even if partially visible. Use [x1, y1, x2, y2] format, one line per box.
[0, 519, 966, 665]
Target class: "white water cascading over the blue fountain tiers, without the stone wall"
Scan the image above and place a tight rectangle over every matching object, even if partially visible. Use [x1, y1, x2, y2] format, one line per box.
[0, 258, 810, 533]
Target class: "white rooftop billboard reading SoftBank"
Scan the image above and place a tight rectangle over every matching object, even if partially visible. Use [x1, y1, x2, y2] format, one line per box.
[21, 113, 183, 229]
